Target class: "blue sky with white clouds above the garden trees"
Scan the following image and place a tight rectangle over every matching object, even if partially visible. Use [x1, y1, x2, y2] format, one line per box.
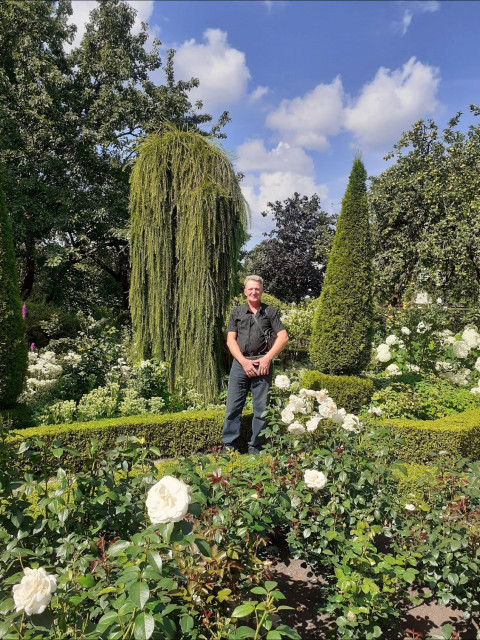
[72, 0, 480, 247]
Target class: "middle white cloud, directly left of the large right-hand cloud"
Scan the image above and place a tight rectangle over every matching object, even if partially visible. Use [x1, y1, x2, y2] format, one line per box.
[266, 76, 344, 151]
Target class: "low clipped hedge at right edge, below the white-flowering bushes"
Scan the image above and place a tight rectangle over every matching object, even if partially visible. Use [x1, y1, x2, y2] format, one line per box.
[379, 409, 480, 464]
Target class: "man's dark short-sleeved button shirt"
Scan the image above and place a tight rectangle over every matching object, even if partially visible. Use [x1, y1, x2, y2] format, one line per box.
[227, 302, 285, 356]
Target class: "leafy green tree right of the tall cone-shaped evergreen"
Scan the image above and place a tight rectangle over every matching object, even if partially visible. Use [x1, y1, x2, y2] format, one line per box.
[369, 106, 480, 304]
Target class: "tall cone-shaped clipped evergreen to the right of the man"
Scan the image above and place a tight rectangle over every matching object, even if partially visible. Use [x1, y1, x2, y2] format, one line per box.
[310, 157, 373, 375]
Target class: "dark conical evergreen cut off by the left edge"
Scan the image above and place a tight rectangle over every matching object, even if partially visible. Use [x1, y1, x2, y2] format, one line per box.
[0, 187, 28, 408]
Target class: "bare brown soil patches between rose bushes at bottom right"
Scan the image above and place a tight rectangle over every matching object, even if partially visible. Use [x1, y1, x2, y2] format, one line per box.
[272, 558, 477, 640]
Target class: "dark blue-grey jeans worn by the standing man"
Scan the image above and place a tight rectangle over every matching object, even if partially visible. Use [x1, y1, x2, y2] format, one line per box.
[222, 360, 273, 448]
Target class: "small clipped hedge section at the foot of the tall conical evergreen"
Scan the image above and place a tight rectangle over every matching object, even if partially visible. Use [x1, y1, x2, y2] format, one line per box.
[300, 371, 375, 413]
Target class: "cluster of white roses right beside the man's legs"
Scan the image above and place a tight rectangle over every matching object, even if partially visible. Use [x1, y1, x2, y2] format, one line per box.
[280, 384, 361, 435]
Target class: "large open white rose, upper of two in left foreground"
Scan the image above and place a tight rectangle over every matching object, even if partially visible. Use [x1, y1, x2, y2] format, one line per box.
[145, 476, 191, 524]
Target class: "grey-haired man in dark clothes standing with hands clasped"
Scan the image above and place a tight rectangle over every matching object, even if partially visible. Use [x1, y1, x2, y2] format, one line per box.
[222, 275, 288, 455]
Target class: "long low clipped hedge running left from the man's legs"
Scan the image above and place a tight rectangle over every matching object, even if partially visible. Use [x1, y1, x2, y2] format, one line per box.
[7, 410, 252, 469]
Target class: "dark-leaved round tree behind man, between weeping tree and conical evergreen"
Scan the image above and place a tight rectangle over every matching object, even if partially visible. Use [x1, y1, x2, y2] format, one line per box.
[245, 193, 335, 302]
